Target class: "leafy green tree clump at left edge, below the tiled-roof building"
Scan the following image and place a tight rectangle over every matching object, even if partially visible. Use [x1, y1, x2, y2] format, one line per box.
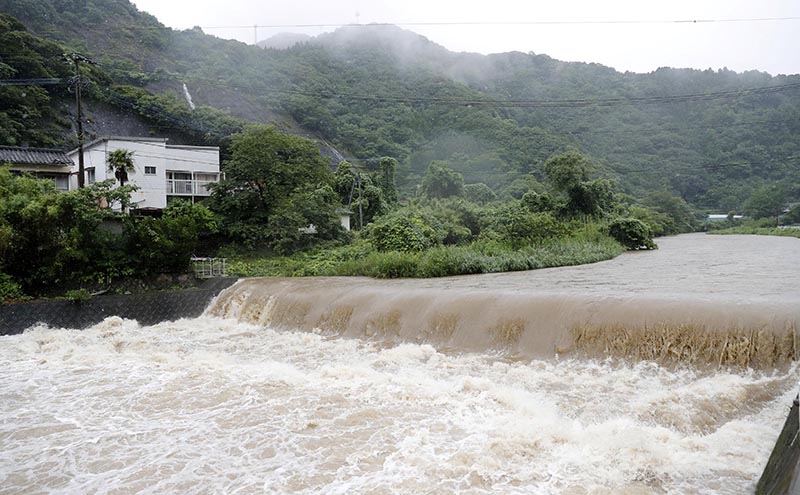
[0, 168, 130, 295]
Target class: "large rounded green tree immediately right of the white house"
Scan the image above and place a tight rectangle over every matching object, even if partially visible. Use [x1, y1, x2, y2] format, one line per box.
[209, 125, 340, 252]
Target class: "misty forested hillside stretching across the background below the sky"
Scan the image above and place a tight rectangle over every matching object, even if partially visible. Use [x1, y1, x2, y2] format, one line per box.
[0, 0, 800, 212]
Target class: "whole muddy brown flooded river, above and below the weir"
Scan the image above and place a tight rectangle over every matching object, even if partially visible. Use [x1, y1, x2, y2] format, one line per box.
[0, 235, 800, 494]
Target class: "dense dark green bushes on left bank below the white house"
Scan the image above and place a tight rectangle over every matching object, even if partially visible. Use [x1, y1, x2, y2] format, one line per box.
[0, 168, 215, 299]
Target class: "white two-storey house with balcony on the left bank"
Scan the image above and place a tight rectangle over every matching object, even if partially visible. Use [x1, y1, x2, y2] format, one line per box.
[67, 136, 221, 209]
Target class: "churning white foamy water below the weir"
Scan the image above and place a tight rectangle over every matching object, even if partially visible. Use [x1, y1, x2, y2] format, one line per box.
[0, 317, 800, 495]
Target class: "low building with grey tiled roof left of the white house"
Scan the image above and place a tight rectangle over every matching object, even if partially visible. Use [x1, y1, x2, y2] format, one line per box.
[0, 146, 72, 191]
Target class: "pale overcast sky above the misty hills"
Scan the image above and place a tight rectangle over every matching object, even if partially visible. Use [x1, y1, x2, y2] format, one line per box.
[128, 0, 800, 74]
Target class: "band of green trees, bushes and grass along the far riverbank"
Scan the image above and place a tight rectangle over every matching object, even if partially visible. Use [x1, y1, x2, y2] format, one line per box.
[0, 126, 668, 299]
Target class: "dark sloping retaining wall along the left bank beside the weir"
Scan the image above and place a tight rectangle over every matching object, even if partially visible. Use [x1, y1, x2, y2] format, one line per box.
[0, 278, 236, 335]
